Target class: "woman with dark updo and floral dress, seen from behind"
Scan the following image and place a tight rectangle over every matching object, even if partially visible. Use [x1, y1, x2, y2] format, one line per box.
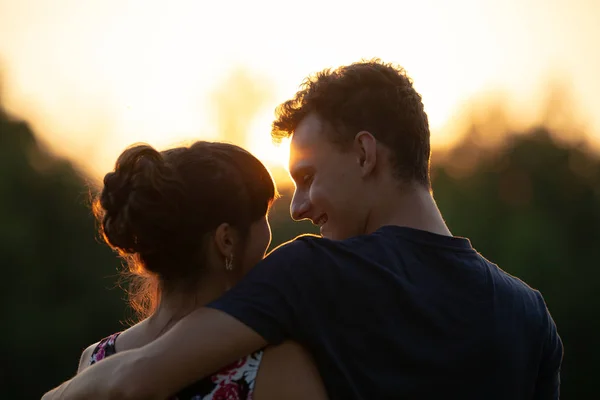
[78, 141, 326, 400]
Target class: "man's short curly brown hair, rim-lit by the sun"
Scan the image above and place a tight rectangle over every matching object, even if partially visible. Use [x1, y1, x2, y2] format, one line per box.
[271, 59, 430, 186]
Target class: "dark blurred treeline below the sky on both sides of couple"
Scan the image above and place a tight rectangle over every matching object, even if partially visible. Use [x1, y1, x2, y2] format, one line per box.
[0, 98, 600, 399]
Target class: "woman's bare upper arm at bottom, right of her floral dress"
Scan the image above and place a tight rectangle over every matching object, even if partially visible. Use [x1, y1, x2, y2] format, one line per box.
[254, 341, 327, 400]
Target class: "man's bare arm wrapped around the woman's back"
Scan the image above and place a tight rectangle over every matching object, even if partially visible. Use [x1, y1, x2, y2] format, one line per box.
[43, 308, 267, 400]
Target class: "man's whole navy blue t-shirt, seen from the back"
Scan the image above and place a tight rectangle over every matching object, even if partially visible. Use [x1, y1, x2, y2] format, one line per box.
[209, 226, 563, 400]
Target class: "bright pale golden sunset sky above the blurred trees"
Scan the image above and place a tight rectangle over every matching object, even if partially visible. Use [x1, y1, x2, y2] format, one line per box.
[0, 0, 600, 181]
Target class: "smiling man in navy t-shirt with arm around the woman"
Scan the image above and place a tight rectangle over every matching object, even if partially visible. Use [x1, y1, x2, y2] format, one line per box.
[47, 60, 562, 399]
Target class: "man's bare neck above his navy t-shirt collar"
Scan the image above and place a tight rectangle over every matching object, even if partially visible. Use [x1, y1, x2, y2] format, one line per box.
[367, 184, 452, 236]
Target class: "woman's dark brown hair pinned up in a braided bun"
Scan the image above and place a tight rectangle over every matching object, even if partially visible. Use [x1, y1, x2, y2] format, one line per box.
[93, 141, 277, 317]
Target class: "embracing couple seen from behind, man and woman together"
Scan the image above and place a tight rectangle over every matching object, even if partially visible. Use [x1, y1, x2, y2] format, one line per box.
[44, 60, 563, 400]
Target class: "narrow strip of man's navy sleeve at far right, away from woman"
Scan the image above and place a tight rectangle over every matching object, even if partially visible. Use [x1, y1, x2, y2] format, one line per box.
[534, 294, 563, 400]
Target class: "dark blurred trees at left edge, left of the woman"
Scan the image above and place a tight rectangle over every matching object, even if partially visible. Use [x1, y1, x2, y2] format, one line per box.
[0, 103, 124, 399]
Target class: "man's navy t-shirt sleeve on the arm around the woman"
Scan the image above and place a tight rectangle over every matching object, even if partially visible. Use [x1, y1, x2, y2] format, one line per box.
[208, 238, 316, 344]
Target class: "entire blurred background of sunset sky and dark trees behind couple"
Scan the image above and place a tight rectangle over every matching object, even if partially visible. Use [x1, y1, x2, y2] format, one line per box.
[0, 0, 600, 399]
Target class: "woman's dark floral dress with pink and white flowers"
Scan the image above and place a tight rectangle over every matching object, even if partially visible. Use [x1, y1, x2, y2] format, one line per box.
[90, 332, 263, 400]
